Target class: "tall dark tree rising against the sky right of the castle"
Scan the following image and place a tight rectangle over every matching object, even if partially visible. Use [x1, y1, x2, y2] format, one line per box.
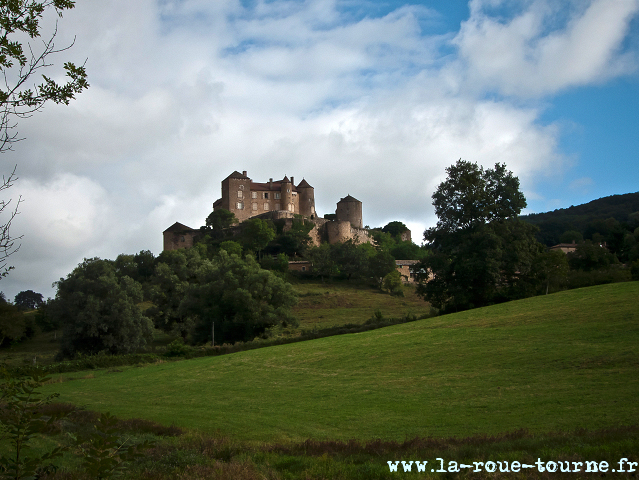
[417, 160, 542, 310]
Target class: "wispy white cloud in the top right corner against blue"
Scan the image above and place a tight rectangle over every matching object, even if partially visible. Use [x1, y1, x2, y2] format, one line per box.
[454, 0, 639, 96]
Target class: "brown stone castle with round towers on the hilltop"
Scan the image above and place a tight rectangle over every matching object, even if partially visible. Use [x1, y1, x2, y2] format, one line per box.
[163, 171, 372, 250]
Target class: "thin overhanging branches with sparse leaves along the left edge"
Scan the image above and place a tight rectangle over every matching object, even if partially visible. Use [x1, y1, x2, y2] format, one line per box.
[0, 0, 89, 278]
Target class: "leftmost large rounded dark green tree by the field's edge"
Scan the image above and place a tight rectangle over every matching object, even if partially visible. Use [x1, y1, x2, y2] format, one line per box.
[54, 258, 152, 357]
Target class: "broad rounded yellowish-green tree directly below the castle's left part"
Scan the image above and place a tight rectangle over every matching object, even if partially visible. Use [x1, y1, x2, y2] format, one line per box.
[180, 250, 297, 343]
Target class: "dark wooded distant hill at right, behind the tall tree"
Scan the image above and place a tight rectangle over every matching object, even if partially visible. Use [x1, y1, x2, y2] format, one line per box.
[521, 192, 639, 249]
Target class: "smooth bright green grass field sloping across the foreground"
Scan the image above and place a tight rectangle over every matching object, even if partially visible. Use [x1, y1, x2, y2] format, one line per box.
[46, 282, 639, 441]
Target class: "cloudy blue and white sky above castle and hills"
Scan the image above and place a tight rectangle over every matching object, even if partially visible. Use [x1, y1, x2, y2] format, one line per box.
[0, 0, 639, 299]
